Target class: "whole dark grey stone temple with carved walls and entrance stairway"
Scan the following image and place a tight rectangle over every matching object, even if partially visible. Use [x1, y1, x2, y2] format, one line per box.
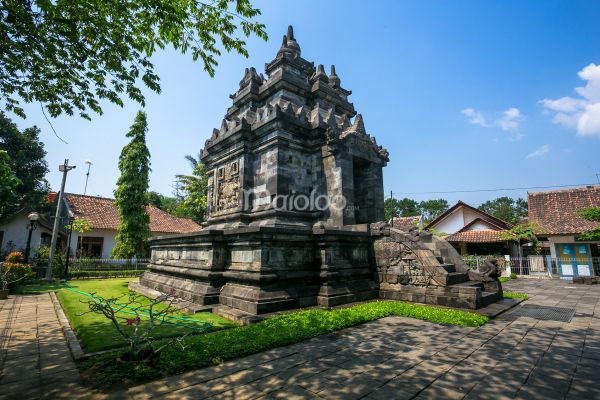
[134, 27, 501, 322]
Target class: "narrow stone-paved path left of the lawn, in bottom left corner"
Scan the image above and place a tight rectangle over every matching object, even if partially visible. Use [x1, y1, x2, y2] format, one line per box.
[0, 293, 88, 399]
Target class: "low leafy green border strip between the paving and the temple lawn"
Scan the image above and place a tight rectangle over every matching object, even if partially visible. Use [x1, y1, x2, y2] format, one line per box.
[81, 301, 488, 385]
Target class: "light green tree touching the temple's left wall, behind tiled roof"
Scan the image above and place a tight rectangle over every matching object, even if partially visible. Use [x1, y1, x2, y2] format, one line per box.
[176, 154, 208, 223]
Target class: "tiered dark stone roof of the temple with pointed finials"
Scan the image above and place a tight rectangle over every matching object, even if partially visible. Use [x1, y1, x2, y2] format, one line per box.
[202, 26, 388, 161]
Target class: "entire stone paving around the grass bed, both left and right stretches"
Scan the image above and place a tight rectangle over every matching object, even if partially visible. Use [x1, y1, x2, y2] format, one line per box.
[0, 279, 600, 400]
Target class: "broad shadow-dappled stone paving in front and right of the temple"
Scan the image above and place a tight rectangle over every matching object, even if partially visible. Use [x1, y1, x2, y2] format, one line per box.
[123, 279, 600, 400]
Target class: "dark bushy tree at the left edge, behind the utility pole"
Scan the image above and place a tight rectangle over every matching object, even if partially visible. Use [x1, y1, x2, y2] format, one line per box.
[0, 111, 50, 213]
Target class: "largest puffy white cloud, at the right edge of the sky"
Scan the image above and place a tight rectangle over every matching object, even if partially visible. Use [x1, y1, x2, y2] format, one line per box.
[539, 63, 600, 137]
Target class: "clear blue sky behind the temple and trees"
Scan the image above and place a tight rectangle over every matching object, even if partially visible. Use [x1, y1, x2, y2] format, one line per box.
[5, 0, 600, 205]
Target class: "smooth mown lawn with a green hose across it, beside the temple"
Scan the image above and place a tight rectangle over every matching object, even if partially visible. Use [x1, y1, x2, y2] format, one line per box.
[55, 278, 237, 353]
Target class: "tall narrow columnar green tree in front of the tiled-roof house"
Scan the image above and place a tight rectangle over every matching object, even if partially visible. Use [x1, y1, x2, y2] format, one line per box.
[112, 111, 150, 258]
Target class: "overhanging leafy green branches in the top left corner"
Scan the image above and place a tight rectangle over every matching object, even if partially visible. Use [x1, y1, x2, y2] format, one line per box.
[0, 0, 267, 119]
